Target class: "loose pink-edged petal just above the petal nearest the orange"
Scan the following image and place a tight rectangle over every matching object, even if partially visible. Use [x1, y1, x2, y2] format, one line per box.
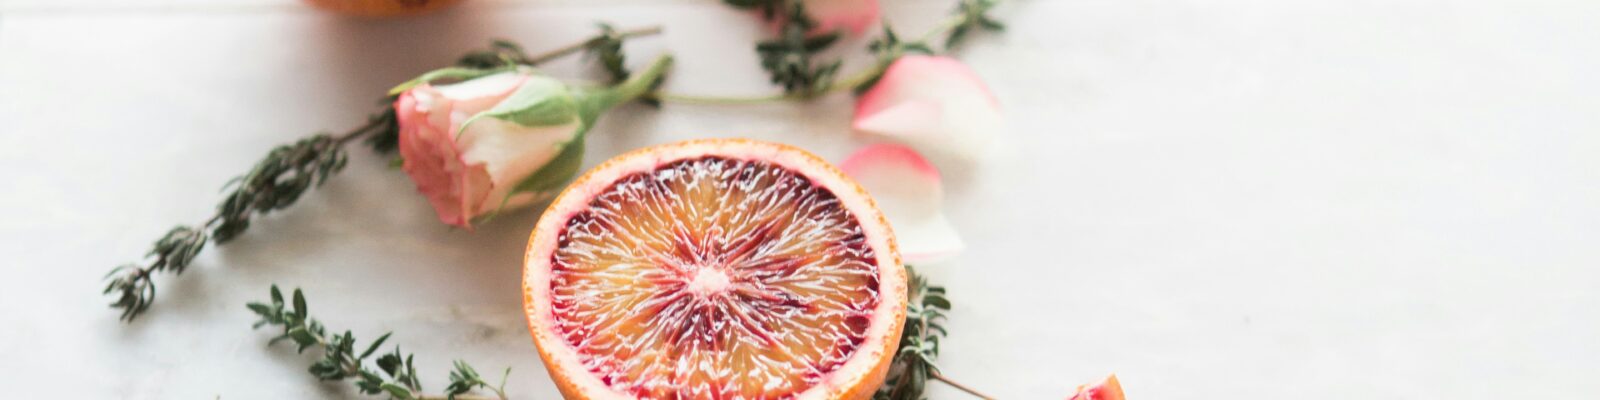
[851, 54, 1005, 160]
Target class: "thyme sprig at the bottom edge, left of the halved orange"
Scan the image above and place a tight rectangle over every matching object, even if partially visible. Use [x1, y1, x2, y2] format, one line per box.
[246, 285, 510, 400]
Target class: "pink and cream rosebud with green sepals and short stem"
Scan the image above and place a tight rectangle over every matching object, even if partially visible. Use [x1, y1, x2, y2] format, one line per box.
[392, 58, 672, 229]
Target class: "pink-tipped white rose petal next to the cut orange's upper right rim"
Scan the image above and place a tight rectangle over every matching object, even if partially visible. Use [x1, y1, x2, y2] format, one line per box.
[840, 144, 965, 262]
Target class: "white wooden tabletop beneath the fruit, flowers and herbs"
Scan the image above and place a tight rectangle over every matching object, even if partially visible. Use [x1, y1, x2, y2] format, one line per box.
[0, 0, 1600, 400]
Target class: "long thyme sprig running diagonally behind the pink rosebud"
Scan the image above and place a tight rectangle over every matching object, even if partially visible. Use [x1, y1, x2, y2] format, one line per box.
[101, 26, 661, 322]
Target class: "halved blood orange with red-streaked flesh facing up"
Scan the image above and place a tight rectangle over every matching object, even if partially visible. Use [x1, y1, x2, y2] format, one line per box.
[523, 139, 906, 398]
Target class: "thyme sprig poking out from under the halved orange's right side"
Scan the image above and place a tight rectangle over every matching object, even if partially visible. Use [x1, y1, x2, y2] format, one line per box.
[872, 266, 992, 400]
